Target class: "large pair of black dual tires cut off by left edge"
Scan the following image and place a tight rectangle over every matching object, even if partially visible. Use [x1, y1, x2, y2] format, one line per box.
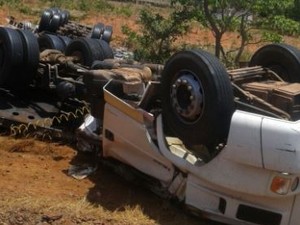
[0, 27, 39, 88]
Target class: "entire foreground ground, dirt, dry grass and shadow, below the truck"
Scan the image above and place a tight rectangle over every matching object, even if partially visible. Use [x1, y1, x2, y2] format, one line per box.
[0, 136, 220, 225]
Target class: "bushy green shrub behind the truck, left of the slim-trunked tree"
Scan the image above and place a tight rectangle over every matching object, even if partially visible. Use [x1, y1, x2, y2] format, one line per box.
[122, 6, 191, 63]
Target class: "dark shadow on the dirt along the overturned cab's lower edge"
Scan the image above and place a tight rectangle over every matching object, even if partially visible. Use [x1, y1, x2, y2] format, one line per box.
[71, 152, 225, 225]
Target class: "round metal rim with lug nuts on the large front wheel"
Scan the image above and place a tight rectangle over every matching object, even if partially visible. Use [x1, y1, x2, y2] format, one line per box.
[171, 71, 205, 123]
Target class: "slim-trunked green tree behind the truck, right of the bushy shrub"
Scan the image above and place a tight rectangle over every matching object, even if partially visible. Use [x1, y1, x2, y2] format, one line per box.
[172, 0, 299, 66]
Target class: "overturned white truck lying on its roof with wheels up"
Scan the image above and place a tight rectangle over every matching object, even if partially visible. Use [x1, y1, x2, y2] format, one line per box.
[0, 11, 300, 225]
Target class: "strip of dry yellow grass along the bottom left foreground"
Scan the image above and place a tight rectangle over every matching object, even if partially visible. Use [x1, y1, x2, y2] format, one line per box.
[0, 192, 156, 225]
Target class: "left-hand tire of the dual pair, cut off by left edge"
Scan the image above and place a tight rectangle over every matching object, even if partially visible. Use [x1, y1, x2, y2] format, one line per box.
[0, 27, 24, 87]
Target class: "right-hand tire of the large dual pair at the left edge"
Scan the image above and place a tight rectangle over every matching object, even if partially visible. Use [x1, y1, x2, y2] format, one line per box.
[18, 30, 40, 84]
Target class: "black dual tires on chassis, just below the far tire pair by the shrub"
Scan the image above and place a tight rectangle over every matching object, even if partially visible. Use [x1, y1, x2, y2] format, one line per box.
[65, 38, 104, 66]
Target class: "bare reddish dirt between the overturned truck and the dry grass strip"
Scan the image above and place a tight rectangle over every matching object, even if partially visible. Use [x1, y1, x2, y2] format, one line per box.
[0, 136, 216, 225]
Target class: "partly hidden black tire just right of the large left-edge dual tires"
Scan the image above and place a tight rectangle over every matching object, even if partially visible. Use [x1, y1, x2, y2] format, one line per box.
[38, 34, 66, 52]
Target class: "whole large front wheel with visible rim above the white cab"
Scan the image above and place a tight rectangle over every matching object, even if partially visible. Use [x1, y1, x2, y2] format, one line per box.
[161, 50, 234, 149]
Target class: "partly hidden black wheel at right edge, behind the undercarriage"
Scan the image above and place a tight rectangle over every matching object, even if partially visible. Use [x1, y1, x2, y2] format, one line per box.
[249, 44, 300, 82]
